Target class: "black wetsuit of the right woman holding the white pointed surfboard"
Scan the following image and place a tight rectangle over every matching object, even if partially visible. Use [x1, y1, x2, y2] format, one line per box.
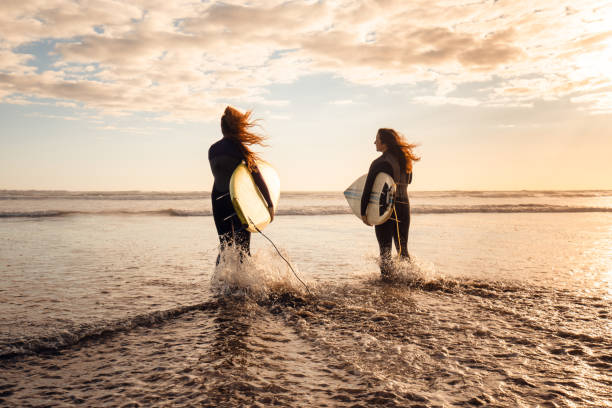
[361, 150, 412, 276]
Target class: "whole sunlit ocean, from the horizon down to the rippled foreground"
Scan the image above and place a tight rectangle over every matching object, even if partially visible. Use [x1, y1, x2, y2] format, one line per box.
[0, 190, 612, 407]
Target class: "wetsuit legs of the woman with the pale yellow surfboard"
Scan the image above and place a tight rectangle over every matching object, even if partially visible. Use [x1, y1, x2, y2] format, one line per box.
[211, 191, 251, 265]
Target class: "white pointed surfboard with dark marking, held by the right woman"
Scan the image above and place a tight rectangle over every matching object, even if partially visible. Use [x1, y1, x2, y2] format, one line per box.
[344, 173, 396, 225]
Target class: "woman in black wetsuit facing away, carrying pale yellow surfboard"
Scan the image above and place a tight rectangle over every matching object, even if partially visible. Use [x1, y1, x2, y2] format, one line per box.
[208, 106, 274, 264]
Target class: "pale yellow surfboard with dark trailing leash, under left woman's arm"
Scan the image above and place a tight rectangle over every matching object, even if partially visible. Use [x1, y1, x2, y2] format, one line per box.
[230, 160, 280, 232]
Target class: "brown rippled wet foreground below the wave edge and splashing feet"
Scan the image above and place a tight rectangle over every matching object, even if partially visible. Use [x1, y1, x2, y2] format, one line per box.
[0, 278, 612, 407]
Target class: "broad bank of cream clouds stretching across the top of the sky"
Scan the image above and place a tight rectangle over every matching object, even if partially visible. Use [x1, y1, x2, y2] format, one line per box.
[0, 0, 612, 121]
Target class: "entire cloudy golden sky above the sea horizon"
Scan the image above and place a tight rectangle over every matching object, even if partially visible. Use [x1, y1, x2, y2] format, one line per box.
[0, 0, 612, 191]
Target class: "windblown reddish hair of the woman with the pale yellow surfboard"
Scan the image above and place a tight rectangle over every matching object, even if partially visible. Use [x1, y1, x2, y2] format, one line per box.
[221, 106, 265, 170]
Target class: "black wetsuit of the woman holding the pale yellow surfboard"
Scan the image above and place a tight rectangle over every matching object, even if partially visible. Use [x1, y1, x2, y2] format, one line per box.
[208, 138, 272, 263]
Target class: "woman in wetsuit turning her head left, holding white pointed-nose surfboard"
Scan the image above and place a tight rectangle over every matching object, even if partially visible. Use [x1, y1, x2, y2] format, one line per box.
[361, 128, 420, 278]
